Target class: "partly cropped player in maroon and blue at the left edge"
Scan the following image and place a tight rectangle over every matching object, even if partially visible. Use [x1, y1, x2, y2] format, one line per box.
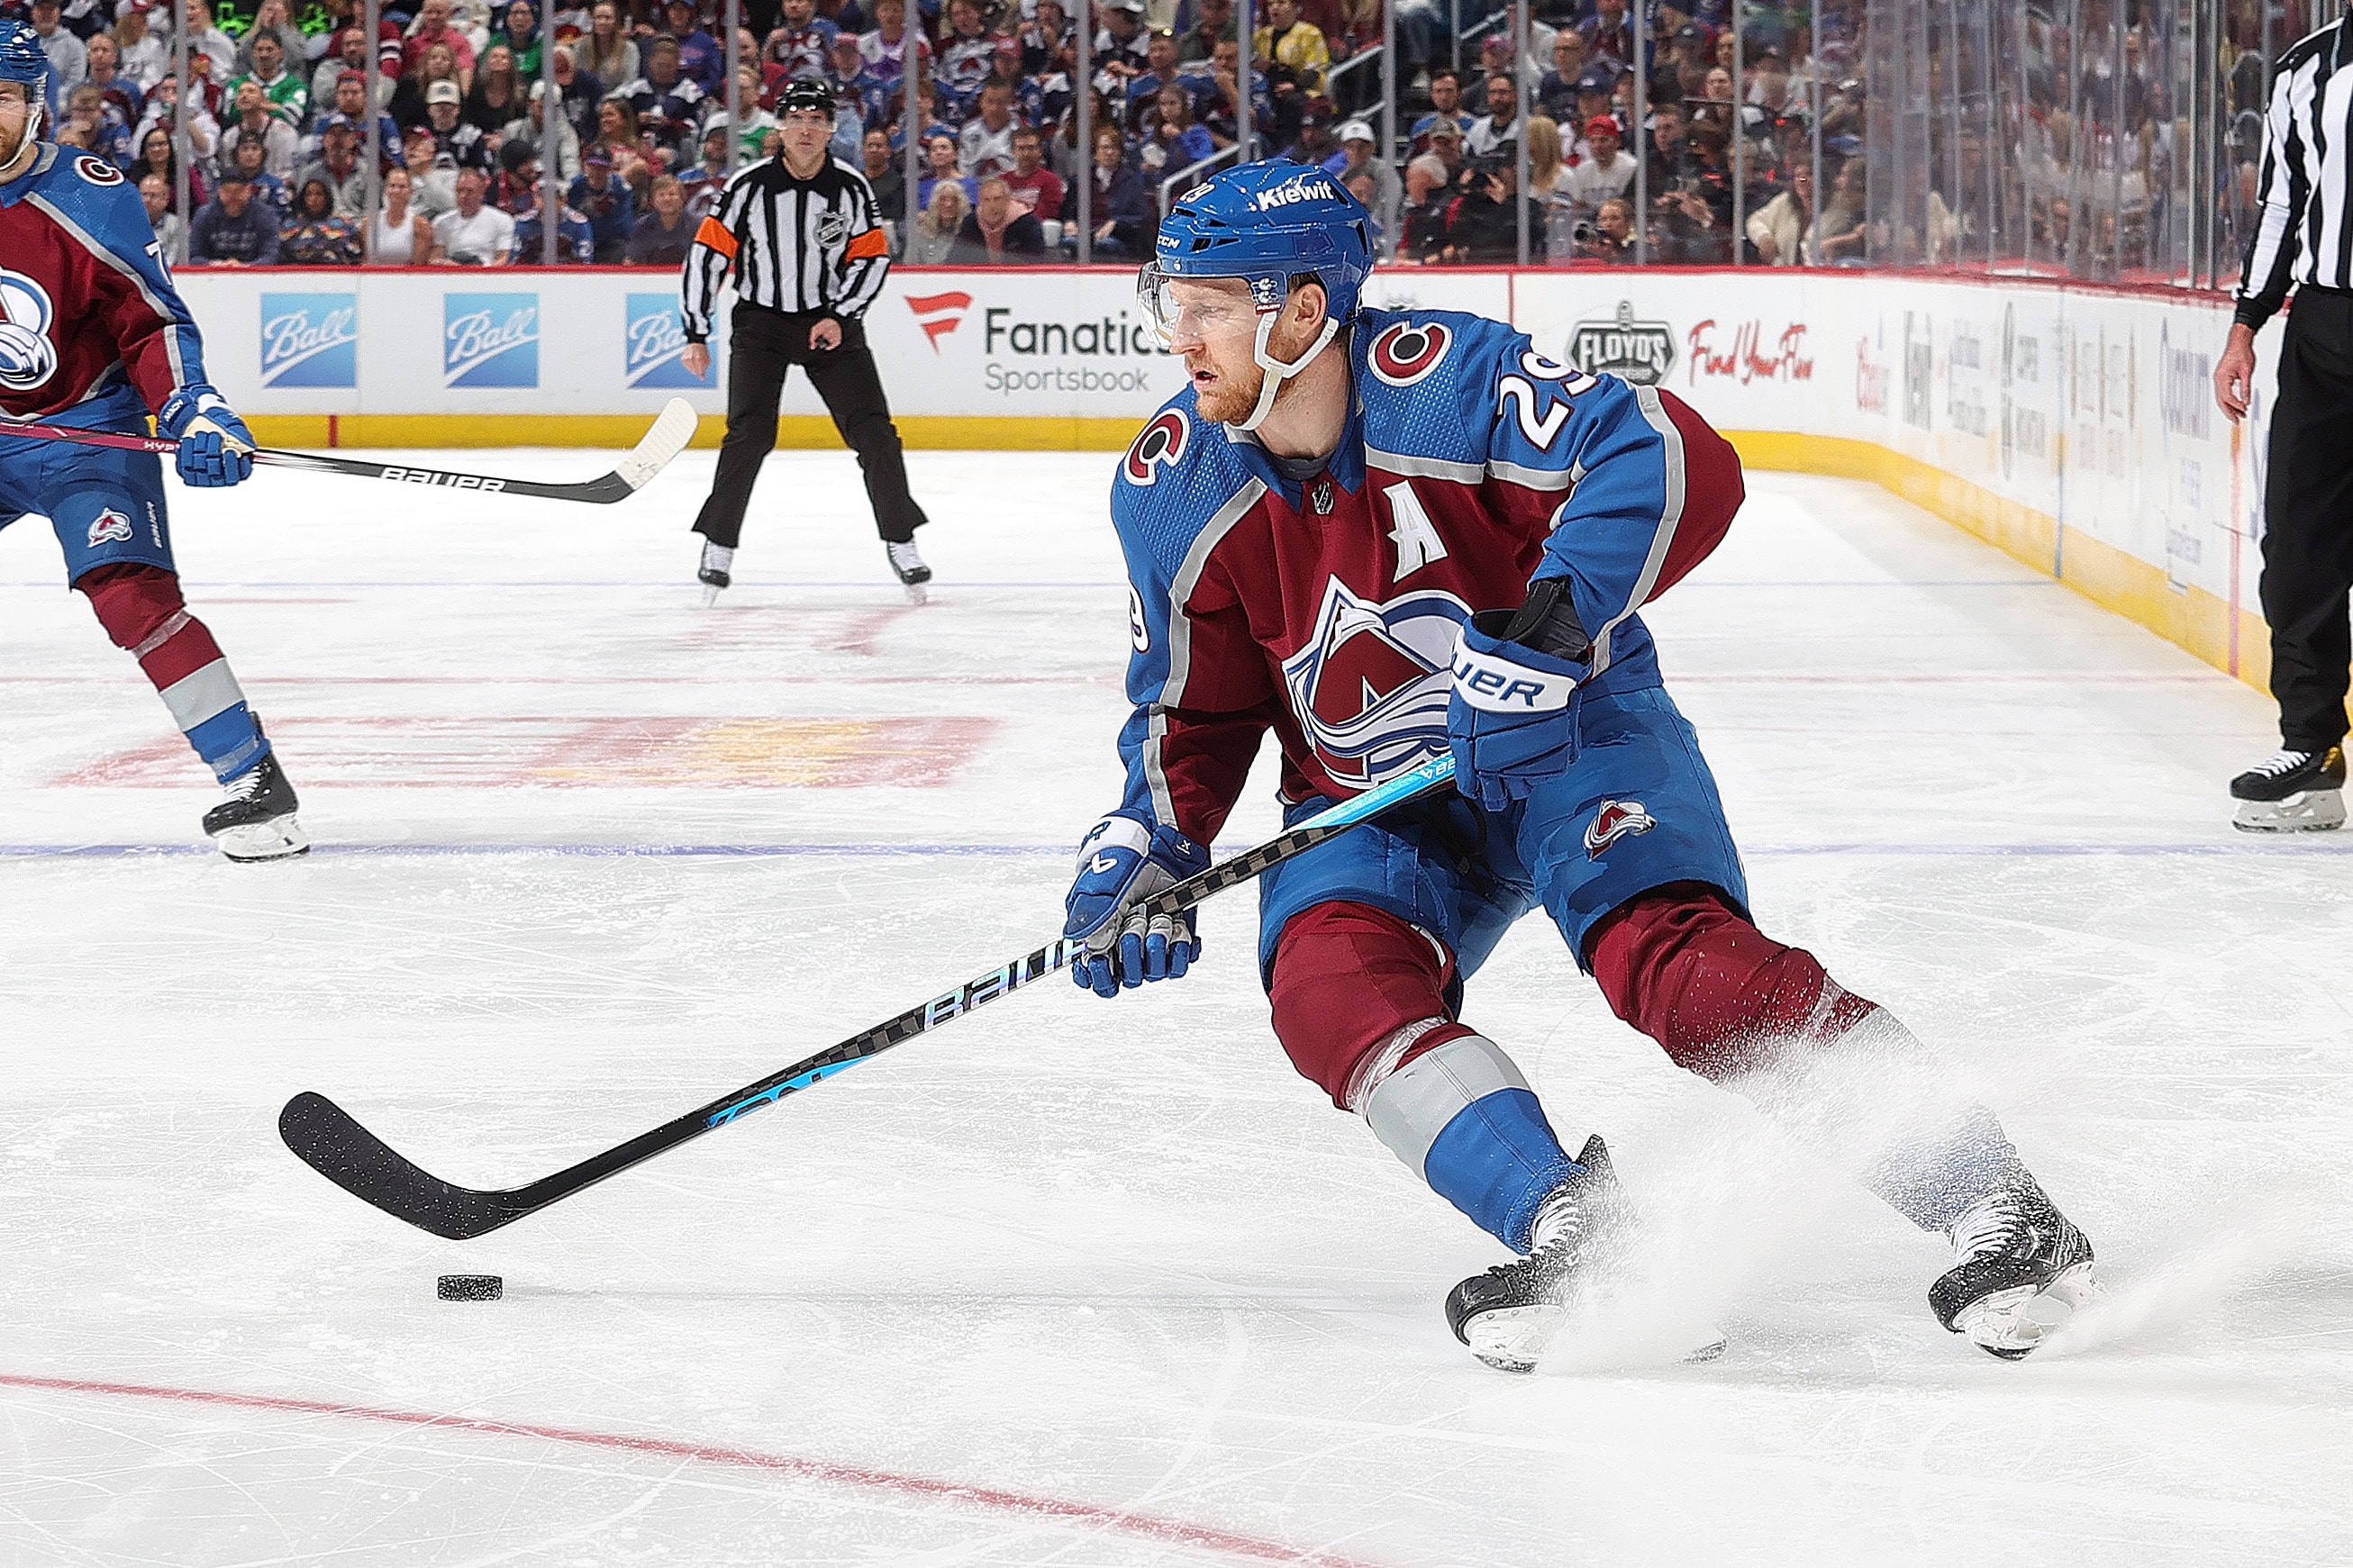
[0, 21, 308, 860]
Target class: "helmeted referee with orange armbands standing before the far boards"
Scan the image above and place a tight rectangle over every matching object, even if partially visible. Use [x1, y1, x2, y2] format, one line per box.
[680, 82, 931, 604]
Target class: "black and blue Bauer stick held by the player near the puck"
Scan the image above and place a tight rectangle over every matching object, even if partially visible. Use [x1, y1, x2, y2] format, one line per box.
[277, 757, 1454, 1241]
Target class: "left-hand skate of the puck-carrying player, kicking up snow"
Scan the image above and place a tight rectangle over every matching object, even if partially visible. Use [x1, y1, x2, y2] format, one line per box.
[1447, 1133, 1725, 1373]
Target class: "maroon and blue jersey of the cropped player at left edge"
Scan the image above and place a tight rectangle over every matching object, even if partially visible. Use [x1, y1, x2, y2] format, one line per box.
[0, 143, 204, 431]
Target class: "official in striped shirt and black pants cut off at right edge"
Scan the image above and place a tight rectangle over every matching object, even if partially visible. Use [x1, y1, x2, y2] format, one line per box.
[2214, 19, 2353, 832]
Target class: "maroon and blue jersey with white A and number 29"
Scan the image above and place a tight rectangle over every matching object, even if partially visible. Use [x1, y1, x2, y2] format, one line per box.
[1111, 311, 1739, 844]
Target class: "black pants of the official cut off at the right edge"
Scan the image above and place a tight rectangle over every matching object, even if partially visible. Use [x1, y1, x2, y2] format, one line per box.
[2261, 286, 2353, 752]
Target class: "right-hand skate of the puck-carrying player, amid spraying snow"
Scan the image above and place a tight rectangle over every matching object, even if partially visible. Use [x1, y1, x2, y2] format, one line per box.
[1927, 1171, 2099, 1361]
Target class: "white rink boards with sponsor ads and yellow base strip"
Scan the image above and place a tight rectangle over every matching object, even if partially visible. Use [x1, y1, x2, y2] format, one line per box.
[181, 268, 2277, 686]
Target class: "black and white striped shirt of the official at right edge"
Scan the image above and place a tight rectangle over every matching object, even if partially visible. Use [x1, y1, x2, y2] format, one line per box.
[2235, 21, 2353, 327]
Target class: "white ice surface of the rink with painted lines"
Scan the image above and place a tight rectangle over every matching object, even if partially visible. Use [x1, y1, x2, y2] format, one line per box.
[0, 451, 2353, 1568]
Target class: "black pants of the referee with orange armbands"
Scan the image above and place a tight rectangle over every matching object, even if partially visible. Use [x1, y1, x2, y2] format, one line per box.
[695, 304, 927, 550]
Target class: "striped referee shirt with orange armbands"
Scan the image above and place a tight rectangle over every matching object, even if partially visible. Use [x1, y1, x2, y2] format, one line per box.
[682, 158, 889, 343]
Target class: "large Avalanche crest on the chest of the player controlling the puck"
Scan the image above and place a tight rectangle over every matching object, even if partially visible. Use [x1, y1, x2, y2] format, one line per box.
[1283, 578, 1471, 790]
